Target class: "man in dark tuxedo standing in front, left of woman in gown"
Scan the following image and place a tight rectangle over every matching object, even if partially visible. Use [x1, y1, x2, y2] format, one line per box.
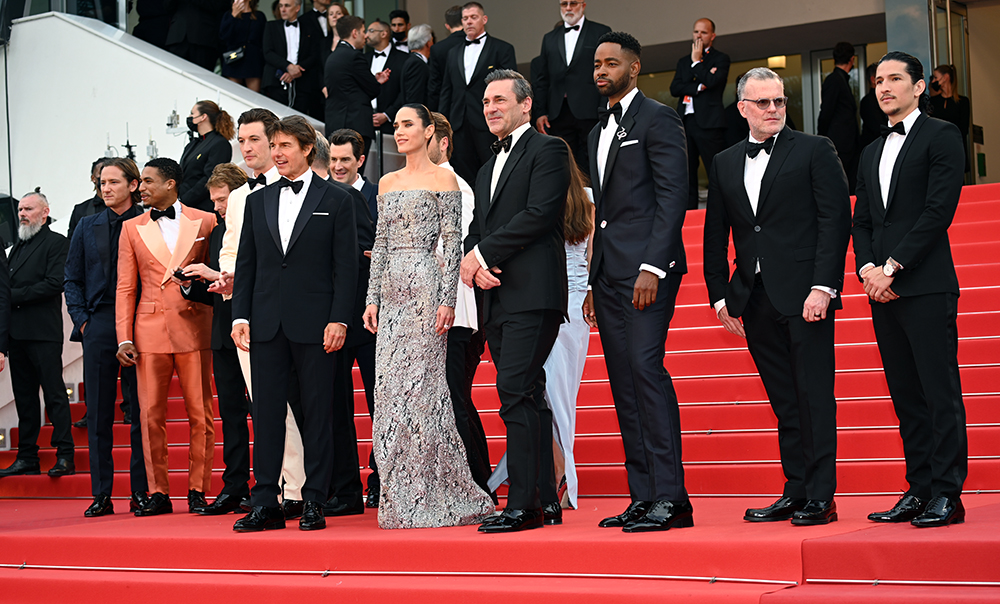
[232, 115, 358, 532]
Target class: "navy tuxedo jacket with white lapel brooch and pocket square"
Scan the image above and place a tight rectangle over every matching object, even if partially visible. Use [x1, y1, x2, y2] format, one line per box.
[587, 92, 688, 298]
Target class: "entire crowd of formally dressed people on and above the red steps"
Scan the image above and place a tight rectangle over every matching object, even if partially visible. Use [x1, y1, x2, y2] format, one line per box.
[0, 0, 967, 533]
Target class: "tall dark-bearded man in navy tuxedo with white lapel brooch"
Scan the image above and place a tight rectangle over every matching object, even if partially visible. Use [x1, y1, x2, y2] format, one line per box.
[583, 32, 694, 532]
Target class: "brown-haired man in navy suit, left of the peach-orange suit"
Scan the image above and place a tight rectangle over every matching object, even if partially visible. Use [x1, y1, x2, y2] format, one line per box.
[63, 158, 149, 518]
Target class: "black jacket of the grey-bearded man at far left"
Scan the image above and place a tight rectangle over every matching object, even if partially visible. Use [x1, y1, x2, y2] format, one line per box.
[9, 224, 69, 343]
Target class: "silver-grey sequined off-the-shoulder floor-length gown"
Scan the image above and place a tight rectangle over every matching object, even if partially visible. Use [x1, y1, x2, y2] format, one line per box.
[367, 190, 493, 529]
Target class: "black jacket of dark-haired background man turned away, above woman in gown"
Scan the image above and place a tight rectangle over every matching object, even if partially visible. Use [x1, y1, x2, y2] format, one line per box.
[324, 40, 382, 139]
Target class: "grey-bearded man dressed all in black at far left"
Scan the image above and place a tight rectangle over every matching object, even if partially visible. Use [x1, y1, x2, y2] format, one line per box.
[0, 189, 76, 477]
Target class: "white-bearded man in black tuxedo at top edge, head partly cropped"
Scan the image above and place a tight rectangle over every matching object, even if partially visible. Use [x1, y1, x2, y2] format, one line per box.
[531, 0, 611, 174]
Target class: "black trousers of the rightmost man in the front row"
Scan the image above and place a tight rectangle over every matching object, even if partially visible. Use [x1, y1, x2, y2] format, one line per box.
[872, 293, 969, 499]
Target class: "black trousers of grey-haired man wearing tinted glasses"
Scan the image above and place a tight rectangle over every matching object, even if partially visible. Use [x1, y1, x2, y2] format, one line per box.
[743, 277, 837, 501]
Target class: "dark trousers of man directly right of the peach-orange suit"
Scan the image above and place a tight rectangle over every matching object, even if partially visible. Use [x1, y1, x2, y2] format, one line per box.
[212, 348, 250, 499]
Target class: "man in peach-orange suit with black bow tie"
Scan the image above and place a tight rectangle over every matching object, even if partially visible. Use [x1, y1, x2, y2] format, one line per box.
[115, 158, 216, 516]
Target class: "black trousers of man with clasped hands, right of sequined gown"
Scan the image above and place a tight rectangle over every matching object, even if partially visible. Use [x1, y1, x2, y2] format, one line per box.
[485, 302, 562, 509]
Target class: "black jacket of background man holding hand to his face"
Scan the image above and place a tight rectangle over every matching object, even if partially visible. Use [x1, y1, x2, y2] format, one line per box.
[670, 46, 729, 128]
